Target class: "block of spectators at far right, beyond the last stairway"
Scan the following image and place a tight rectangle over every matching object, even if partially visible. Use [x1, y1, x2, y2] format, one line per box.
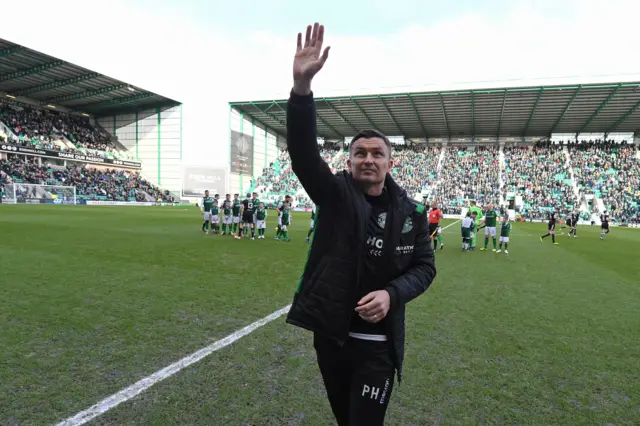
[568, 140, 640, 223]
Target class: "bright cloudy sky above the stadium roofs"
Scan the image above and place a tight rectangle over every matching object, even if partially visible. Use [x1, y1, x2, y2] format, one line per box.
[0, 0, 640, 164]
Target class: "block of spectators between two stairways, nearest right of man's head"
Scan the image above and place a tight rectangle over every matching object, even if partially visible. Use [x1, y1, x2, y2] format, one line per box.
[433, 146, 500, 214]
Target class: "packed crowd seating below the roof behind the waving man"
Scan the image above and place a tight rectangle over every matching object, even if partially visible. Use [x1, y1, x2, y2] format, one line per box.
[245, 142, 640, 223]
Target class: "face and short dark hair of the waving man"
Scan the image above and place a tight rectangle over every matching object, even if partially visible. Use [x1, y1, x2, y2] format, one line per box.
[347, 138, 393, 184]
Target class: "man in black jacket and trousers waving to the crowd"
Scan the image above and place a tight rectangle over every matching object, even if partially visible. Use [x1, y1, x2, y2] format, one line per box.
[287, 23, 436, 426]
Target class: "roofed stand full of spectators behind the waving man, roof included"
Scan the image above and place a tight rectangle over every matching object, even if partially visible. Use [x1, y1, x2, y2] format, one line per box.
[229, 78, 640, 223]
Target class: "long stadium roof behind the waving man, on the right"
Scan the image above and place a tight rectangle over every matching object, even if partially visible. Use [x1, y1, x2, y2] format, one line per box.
[230, 82, 640, 139]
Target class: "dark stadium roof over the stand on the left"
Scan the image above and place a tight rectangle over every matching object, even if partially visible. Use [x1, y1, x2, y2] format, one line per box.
[0, 39, 180, 117]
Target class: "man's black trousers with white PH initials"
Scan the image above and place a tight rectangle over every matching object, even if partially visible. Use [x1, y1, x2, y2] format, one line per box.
[313, 334, 395, 426]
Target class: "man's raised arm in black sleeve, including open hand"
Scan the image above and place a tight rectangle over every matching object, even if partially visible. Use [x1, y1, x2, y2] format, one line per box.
[287, 23, 337, 205]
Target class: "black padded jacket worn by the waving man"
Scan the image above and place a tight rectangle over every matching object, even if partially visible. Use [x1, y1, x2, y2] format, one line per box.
[287, 93, 436, 380]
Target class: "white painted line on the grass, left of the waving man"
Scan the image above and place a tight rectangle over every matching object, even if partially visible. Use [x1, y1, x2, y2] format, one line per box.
[56, 305, 291, 426]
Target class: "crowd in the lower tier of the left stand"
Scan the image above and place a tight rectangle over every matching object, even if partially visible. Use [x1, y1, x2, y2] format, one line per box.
[0, 155, 174, 202]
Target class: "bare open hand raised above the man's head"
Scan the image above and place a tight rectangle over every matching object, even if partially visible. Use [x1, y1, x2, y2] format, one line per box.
[293, 22, 329, 95]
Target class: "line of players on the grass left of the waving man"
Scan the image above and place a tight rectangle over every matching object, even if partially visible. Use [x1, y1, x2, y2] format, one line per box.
[200, 190, 315, 242]
